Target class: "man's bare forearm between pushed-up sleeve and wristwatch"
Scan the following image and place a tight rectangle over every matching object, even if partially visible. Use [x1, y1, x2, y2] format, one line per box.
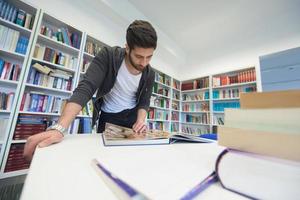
[58, 102, 82, 128]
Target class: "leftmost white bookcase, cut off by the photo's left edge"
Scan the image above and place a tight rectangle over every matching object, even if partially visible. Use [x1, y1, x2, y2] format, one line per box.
[0, 0, 40, 178]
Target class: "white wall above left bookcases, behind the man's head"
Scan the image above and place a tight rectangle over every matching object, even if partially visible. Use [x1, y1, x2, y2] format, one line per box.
[24, 0, 185, 78]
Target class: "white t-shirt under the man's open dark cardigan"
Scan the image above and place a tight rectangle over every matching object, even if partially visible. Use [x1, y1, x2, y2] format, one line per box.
[101, 59, 142, 113]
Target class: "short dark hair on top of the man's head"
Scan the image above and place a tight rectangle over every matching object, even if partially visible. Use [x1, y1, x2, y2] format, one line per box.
[126, 20, 157, 49]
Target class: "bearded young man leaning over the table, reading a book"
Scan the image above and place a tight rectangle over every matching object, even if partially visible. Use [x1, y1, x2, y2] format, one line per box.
[24, 20, 157, 160]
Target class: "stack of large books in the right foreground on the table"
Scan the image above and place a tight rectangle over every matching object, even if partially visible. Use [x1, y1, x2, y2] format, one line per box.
[216, 90, 300, 199]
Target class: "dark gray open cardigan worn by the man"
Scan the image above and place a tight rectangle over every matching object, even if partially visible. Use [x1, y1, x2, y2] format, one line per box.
[68, 47, 155, 126]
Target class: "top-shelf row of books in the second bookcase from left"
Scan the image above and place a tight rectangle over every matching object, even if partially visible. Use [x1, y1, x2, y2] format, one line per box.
[40, 25, 81, 49]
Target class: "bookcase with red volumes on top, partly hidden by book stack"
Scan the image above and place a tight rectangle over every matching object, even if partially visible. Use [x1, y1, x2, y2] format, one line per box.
[211, 67, 257, 129]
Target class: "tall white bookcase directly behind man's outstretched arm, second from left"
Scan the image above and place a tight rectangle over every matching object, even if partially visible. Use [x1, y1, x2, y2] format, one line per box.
[1, 10, 84, 177]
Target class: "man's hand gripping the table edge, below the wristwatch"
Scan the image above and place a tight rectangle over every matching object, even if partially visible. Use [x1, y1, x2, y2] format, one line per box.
[23, 130, 63, 161]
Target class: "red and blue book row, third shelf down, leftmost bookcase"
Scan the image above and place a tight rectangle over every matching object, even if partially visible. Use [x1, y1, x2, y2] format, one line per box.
[0, 58, 21, 81]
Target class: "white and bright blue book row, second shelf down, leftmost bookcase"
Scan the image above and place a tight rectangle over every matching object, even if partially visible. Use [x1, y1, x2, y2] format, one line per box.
[0, 24, 29, 54]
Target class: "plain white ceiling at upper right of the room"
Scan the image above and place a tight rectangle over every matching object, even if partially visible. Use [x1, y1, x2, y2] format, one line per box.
[128, 0, 300, 72]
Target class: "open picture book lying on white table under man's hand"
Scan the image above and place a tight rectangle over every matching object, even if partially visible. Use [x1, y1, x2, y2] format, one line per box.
[102, 123, 214, 146]
